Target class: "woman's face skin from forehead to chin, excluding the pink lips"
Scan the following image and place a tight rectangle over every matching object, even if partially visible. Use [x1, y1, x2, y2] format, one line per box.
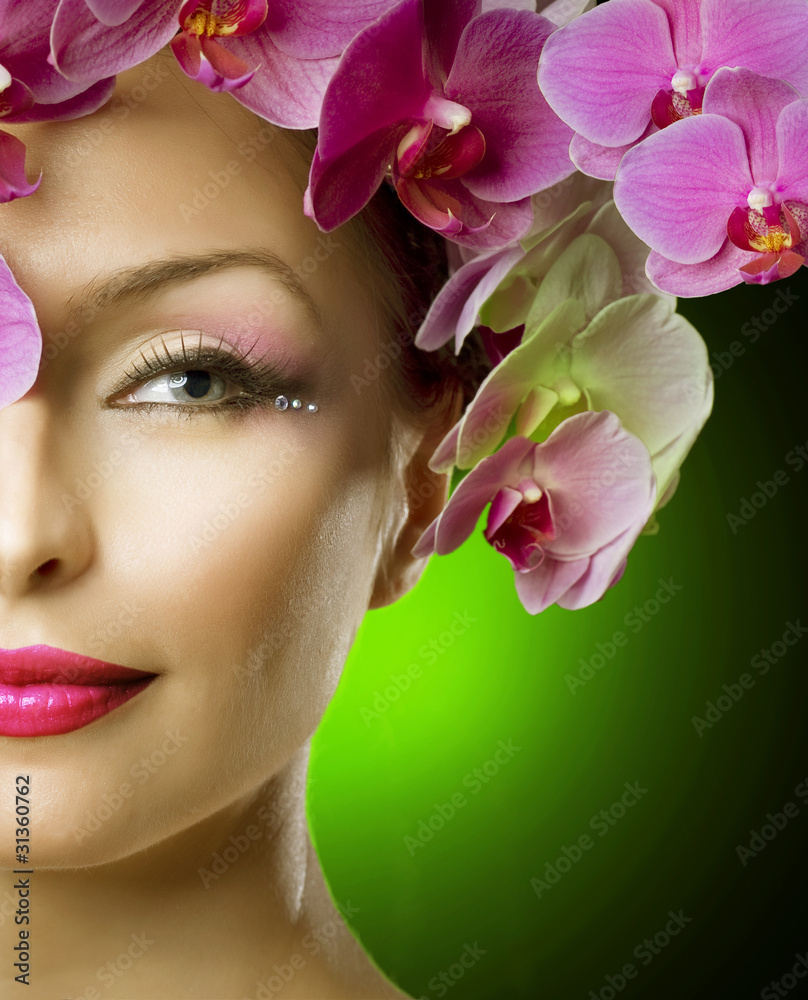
[0, 57, 430, 867]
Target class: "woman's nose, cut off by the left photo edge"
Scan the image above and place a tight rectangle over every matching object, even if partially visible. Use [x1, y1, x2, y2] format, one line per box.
[0, 392, 92, 600]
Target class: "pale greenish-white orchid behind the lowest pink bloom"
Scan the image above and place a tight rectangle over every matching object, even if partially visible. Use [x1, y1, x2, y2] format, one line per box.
[430, 229, 713, 500]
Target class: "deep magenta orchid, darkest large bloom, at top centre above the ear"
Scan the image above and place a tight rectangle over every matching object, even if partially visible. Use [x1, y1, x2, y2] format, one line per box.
[306, 0, 573, 248]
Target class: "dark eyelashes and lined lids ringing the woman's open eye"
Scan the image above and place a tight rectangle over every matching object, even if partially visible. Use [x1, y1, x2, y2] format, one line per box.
[112, 342, 306, 418]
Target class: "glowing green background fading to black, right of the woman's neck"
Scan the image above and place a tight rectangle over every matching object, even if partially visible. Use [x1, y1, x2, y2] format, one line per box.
[309, 269, 808, 1000]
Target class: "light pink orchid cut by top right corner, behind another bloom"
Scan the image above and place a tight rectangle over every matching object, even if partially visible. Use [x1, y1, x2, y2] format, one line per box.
[539, 0, 808, 179]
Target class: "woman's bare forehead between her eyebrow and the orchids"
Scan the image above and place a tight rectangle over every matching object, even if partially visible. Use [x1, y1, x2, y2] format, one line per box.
[0, 52, 364, 336]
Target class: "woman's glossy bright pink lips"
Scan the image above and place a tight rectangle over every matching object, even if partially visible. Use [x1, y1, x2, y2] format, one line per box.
[0, 646, 156, 736]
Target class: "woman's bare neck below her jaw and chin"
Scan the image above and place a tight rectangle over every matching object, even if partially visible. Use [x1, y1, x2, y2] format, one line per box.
[0, 746, 399, 1000]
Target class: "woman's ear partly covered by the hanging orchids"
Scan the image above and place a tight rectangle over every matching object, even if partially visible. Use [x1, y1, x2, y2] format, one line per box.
[368, 392, 463, 608]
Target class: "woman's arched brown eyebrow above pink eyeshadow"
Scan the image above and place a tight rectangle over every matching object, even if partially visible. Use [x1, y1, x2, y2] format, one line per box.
[67, 247, 321, 324]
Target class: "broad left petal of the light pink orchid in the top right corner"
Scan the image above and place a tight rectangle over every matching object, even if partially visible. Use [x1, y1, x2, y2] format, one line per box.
[539, 0, 676, 146]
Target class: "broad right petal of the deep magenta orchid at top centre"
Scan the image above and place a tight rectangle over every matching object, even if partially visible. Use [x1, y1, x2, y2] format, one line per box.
[445, 10, 573, 202]
